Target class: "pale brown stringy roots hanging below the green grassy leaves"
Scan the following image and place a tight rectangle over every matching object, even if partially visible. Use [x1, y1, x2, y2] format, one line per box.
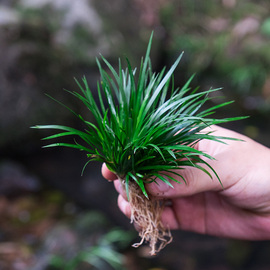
[122, 181, 172, 255]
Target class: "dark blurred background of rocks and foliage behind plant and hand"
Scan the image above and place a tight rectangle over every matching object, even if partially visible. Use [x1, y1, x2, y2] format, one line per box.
[0, 0, 270, 270]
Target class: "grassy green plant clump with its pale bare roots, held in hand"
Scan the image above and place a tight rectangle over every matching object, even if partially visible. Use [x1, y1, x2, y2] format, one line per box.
[32, 35, 246, 255]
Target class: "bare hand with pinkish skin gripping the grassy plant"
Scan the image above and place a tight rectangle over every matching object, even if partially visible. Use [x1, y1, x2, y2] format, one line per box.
[102, 126, 270, 240]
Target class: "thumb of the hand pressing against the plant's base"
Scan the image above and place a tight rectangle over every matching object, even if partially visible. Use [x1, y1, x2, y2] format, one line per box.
[146, 162, 223, 198]
